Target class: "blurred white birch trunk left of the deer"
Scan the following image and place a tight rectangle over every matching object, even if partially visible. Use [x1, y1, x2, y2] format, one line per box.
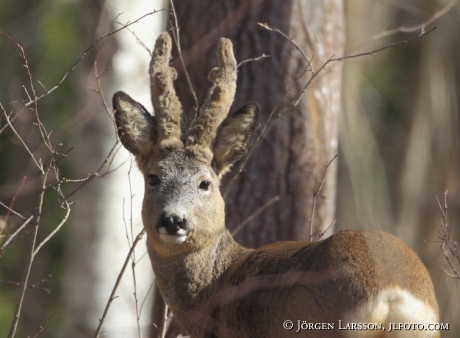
[61, 0, 166, 338]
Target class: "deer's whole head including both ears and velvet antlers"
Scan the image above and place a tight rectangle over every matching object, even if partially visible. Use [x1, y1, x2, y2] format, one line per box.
[113, 33, 259, 256]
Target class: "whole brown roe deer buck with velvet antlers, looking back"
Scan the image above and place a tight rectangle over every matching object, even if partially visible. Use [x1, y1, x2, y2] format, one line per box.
[113, 33, 439, 337]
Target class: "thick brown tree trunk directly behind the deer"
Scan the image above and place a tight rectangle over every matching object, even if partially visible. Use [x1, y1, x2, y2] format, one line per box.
[153, 0, 344, 337]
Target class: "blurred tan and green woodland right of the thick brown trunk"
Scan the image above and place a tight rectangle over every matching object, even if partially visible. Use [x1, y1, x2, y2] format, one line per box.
[337, 0, 460, 337]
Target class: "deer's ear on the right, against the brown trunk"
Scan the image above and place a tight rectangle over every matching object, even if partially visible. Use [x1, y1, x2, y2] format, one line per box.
[213, 102, 260, 175]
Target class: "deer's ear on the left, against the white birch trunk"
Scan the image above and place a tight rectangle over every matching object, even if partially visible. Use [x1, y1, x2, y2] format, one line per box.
[112, 91, 157, 158]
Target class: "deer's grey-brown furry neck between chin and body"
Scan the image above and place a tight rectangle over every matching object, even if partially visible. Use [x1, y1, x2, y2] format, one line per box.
[148, 229, 248, 315]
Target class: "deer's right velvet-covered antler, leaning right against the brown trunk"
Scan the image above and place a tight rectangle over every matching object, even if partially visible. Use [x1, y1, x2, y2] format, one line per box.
[187, 38, 236, 160]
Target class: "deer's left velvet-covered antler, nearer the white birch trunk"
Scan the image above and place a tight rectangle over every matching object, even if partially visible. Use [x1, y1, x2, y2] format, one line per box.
[149, 33, 184, 151]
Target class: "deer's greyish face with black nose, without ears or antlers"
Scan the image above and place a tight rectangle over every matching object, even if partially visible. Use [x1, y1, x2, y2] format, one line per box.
[142, 150, 224, 255]
